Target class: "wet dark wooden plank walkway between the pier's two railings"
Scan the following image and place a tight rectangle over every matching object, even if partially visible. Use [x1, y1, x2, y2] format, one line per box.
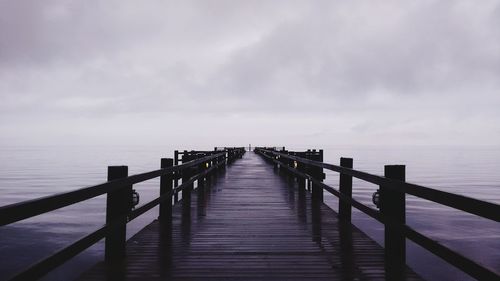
[81, 153, 419, 281]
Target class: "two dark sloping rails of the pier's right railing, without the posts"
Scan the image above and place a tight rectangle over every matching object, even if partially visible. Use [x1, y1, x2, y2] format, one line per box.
[254, 147, 500, 280]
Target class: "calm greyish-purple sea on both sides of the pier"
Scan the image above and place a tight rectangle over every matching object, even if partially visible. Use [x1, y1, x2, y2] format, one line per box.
[0, 146, 500, 280]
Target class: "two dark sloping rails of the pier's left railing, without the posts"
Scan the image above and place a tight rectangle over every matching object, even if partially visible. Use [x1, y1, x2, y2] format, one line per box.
[0, 148, 245, 280]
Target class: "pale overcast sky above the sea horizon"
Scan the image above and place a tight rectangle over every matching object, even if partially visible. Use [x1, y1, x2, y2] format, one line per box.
[0, 0, 500, 145]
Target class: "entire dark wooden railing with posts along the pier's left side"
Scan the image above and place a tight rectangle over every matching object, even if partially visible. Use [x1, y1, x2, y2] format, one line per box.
[0, 147, 245, 280]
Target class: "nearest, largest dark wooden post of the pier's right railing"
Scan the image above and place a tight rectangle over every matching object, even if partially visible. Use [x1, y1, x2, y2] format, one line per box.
[380, 165, 406, 280]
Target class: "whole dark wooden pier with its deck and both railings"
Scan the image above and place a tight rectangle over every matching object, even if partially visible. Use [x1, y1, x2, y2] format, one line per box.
[0, 145, 500, 280]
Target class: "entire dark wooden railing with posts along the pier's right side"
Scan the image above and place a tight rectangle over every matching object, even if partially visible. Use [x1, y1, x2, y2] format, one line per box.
[254, 147, 500, 280]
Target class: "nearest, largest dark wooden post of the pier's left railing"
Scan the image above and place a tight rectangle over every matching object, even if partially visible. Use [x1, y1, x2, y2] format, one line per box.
[104, 166, 132, 262]
